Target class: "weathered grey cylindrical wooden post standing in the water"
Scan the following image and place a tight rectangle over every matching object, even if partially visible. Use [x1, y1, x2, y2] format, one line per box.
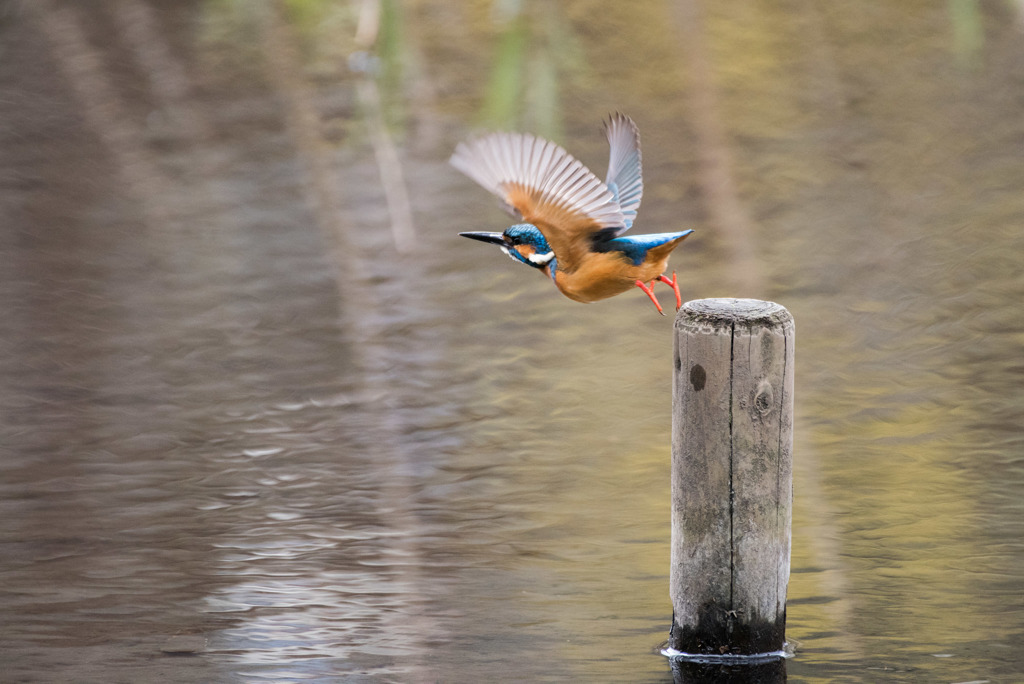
[669, 299, 795, 656]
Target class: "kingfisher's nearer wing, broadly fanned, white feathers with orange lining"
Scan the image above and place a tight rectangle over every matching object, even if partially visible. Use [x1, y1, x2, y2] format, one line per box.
[451, 133, 627, 269]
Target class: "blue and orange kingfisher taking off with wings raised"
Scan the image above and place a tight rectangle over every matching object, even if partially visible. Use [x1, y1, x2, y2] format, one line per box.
[450, 113, 693, 315]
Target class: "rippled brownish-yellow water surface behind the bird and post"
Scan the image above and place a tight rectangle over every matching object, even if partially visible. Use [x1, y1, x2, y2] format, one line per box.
[0, 0, 1024, 682]
